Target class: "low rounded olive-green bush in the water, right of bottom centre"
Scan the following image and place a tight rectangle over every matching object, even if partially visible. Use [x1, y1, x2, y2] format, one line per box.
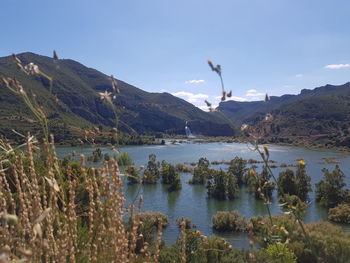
[212, 211, 246, 232]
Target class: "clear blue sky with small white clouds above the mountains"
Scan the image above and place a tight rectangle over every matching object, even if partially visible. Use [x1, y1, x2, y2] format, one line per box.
[0, 0, 350, 109]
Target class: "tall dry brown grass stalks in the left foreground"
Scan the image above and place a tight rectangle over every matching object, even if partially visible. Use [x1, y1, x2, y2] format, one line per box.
[0, 139, 161, 263]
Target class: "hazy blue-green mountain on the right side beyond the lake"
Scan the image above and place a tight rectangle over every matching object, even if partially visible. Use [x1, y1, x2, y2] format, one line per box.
[219, 83, 350, 147]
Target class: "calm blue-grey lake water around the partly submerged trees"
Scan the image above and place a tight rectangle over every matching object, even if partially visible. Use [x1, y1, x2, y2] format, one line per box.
[57, 143, 350, 247]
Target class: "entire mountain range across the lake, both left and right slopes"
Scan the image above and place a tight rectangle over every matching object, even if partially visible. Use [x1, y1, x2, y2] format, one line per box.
[0, 53, 350, 147]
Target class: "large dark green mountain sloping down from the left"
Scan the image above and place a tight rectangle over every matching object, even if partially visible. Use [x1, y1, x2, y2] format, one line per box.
[0, 53, 234, 141]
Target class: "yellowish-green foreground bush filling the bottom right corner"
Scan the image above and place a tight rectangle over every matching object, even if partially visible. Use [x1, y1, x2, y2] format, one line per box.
[250, 216, 350, 263]
